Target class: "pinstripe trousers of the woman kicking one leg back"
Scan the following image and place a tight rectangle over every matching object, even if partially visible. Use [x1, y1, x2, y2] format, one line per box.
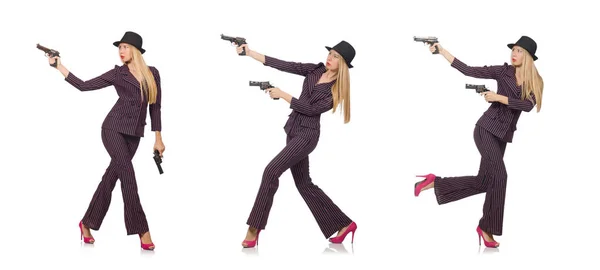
[434, 125, 508, 235]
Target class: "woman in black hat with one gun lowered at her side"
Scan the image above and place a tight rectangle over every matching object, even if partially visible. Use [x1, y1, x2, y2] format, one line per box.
[48, 32, 165, 250]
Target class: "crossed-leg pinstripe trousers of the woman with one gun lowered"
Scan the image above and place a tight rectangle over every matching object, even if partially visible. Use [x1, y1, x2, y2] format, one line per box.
[82, 129, 149, 235]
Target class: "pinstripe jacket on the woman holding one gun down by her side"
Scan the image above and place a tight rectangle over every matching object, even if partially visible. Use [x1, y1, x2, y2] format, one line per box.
[65, 65, 162, 137]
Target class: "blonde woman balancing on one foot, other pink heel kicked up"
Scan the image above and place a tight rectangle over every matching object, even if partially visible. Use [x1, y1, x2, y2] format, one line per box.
[415, 36, 544, 248]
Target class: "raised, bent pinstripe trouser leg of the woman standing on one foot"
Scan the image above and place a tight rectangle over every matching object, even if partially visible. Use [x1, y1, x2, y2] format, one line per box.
[434, 126, 493, 204]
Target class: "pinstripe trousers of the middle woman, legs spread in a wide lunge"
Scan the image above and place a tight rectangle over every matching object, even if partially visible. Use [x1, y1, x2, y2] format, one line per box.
[247, 135, 352, 238]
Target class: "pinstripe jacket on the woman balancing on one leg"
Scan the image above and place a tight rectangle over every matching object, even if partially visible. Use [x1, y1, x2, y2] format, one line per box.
[451, 58, 535, 142]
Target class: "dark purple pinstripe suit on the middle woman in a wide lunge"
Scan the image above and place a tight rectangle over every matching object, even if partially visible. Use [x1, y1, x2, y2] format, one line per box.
[247, 56, 352, 238]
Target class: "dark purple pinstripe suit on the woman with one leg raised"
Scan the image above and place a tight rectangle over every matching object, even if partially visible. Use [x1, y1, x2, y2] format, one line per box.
[434, 58, 535, 235]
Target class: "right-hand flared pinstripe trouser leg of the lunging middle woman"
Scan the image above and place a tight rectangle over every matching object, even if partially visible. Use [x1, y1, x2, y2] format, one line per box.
[291, 156, 352, 238]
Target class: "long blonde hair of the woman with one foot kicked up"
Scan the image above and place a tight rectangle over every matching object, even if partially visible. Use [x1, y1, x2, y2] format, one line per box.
[519, 50, 544, 112]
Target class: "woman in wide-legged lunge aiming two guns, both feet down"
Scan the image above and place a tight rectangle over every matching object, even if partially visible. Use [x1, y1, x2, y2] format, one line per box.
[237, 41, 357, 248]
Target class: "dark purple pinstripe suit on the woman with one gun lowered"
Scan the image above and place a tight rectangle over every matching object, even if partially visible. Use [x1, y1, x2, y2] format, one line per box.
[65, 65, 162, 235]
